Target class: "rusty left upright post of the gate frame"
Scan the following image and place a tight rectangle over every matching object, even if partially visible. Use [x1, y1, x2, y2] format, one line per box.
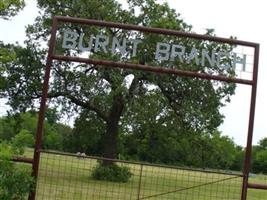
[28, 18, 57, 200]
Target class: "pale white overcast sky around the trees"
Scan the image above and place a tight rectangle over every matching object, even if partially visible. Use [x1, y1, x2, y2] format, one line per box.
[0, 0, 267, 146]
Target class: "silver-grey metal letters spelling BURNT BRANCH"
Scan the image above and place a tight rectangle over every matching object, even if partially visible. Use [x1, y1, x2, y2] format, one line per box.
[62, 30, 246, 71]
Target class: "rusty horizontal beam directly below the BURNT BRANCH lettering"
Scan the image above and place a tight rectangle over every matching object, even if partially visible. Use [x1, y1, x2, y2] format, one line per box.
[52, 55, 253, 85]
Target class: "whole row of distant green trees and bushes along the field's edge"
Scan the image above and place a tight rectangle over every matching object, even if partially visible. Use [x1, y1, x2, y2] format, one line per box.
[0, 109, 267, 173]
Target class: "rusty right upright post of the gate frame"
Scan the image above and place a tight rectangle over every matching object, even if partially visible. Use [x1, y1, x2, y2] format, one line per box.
[241, 45, 260, 200]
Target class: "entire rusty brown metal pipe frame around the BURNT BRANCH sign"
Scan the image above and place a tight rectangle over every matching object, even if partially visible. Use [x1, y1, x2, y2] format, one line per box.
[24, 16, 262, 200]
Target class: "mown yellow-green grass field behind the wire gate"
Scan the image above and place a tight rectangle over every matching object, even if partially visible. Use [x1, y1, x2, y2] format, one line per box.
[22, 150, 267, 200]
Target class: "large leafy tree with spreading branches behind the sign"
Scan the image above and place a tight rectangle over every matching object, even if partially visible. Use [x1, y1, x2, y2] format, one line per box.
[1, 0, 235, 164]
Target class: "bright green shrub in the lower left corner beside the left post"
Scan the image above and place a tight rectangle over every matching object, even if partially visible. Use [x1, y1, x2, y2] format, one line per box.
[0, 142, 34, 200]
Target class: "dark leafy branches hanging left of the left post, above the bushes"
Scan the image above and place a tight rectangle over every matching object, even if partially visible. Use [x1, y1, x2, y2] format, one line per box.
[0, 45, 43, 112]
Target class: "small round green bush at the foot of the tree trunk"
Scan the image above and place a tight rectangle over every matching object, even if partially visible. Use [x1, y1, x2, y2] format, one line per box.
[92, 163, 132, 183]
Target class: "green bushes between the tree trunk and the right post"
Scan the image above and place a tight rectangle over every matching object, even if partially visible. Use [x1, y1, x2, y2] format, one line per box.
[124, 126, 243, 170]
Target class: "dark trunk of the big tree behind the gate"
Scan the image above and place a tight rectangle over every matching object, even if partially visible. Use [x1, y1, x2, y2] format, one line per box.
[102, 93, 124, 165]
